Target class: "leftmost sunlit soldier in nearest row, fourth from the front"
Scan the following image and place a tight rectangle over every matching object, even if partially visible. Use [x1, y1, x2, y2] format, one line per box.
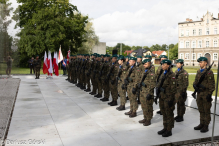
[116, 56, 129, 111]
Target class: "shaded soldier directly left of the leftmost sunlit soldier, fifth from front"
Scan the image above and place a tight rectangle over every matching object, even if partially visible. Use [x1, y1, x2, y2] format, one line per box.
[107, 55, 119, 106]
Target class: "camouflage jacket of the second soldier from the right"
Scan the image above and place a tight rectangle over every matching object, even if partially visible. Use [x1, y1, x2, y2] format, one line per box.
[175, 68, 189, 93]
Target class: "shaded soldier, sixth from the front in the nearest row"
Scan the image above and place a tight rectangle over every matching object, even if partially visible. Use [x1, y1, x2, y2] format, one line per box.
[100, 54, 109, 102]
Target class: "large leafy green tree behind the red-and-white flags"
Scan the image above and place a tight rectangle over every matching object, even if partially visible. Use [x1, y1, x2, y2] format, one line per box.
[13, 0, 88, 56]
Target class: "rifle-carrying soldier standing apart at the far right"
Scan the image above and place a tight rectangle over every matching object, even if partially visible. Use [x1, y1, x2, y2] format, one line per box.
[193, 57, 215, 133]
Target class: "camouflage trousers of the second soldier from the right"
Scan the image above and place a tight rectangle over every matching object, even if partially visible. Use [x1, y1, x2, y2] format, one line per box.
[175, 93, 187, 117]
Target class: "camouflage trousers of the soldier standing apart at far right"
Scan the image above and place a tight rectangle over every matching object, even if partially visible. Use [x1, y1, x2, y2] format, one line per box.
[196, 92, 212, 125]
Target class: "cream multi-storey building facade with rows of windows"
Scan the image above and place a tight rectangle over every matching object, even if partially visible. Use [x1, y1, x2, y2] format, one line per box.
[178, 12, 219, 66]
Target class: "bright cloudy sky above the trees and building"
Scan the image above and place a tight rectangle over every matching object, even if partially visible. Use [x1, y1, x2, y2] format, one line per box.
[7, 0, 219, 46]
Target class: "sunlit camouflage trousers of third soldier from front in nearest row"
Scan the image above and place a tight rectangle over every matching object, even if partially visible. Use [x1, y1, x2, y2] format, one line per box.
[127, 85, 138, 112]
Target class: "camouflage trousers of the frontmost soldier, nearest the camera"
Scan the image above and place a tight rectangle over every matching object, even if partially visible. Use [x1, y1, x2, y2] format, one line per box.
[159, 97, 175, 131]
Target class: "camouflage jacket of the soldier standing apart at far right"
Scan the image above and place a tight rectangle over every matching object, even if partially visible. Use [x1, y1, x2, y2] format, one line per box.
[193, 68, 215, 95]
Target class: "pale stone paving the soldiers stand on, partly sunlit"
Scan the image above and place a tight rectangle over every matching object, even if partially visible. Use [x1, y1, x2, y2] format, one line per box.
[3, 75, 219, 146]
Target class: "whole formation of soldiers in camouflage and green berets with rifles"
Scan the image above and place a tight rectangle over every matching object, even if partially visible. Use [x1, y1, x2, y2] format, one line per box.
[66, 53, 215, 137]
